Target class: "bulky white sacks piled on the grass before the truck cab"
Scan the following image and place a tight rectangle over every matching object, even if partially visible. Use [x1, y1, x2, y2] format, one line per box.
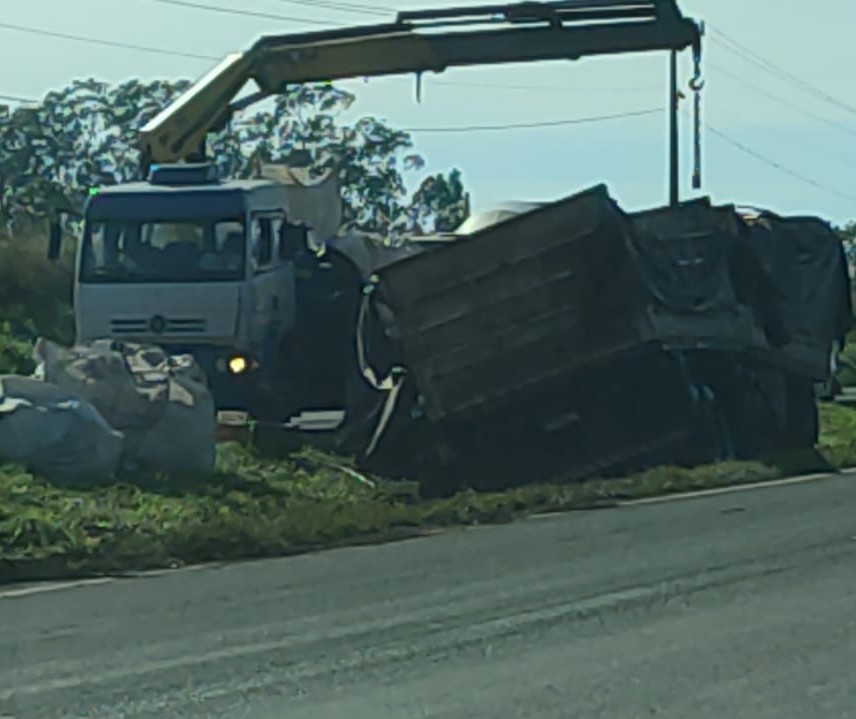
[0, 339, 216, 483]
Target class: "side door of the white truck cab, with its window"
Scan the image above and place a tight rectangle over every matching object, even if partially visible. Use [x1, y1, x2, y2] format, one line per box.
[250, 213, 294, 372]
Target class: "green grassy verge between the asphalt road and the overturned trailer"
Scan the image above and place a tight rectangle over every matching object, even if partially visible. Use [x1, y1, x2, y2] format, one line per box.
[0, 406, 856, 582]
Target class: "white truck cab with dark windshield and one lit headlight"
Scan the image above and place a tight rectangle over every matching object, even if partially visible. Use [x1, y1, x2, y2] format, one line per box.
[52, 164, 341, 422]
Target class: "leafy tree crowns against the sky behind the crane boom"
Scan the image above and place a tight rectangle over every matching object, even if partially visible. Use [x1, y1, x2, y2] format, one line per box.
[0, 79, 469, 235]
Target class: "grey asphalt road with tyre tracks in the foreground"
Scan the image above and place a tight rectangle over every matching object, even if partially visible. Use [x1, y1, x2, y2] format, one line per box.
[0, 477, 856, 719]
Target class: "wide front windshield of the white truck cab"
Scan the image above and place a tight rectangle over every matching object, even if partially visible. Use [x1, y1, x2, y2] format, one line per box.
[80, 219, 246, 283]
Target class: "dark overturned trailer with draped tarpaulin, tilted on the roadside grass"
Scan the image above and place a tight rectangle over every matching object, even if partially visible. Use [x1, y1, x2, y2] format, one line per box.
[324, 186, 853, 496]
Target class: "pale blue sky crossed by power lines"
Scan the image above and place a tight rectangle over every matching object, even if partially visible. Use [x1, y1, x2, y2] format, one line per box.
[0, 0, 856, 222]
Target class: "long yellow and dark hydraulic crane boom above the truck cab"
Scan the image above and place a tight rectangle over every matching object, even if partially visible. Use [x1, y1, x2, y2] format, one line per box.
[140, 0, 701, 173]
